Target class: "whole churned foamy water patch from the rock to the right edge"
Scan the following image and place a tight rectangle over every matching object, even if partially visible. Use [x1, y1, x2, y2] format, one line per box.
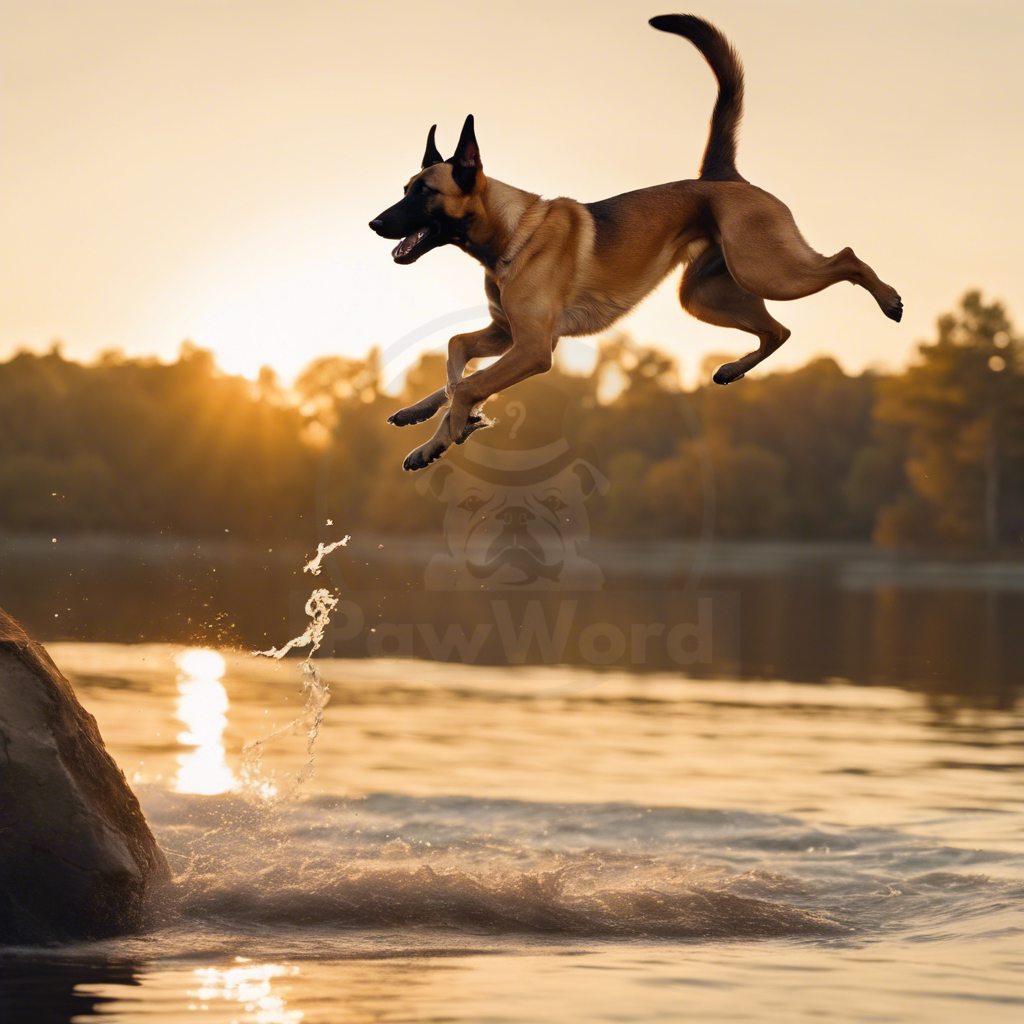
[103, 790, 1024, 955]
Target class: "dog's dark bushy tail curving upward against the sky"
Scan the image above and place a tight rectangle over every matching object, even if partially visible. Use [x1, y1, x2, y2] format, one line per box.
[650, 14, 746, 181]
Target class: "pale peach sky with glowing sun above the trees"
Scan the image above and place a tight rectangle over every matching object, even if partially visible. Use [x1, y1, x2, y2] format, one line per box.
[0, 0, 1024, 380]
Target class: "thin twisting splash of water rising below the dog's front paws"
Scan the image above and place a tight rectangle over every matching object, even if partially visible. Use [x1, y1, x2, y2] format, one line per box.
[242, 535, 350, 803]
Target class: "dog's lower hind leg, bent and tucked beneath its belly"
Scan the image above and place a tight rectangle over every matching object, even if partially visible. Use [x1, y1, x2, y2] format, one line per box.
[679, 245, 790, 384]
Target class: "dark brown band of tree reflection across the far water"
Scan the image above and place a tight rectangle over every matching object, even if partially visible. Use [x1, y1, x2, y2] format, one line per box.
[0, 537, 1024, 700]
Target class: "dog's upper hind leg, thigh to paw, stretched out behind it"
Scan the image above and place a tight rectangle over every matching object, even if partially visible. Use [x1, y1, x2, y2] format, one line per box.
[716, 193, 903, 321]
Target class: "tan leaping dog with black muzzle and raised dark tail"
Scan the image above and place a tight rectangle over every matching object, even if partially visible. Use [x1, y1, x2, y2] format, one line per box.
[370, 14, 903, 470]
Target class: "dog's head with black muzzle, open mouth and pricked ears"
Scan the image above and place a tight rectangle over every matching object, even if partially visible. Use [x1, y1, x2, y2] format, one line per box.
[370, 114, 484, 263]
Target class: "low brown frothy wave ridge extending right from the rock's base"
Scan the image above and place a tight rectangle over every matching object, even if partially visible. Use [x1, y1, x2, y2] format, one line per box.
[166, 863, 847, 939]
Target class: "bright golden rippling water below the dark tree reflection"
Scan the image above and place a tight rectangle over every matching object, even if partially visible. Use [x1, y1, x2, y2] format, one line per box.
[0, 643, 1024, 1024]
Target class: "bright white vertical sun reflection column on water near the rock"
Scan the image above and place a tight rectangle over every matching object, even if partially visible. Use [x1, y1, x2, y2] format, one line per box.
[174, 647, 238, 796]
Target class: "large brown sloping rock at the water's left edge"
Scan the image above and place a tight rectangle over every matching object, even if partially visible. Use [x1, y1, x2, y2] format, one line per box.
[0, 608, 171, 943]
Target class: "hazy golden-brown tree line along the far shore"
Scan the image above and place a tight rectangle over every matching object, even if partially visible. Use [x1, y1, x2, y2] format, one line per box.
[0, 292, 1024, 550]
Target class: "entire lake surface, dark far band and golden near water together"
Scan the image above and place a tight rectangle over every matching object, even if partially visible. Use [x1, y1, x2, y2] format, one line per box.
[0, 542, 1024, 1024]
